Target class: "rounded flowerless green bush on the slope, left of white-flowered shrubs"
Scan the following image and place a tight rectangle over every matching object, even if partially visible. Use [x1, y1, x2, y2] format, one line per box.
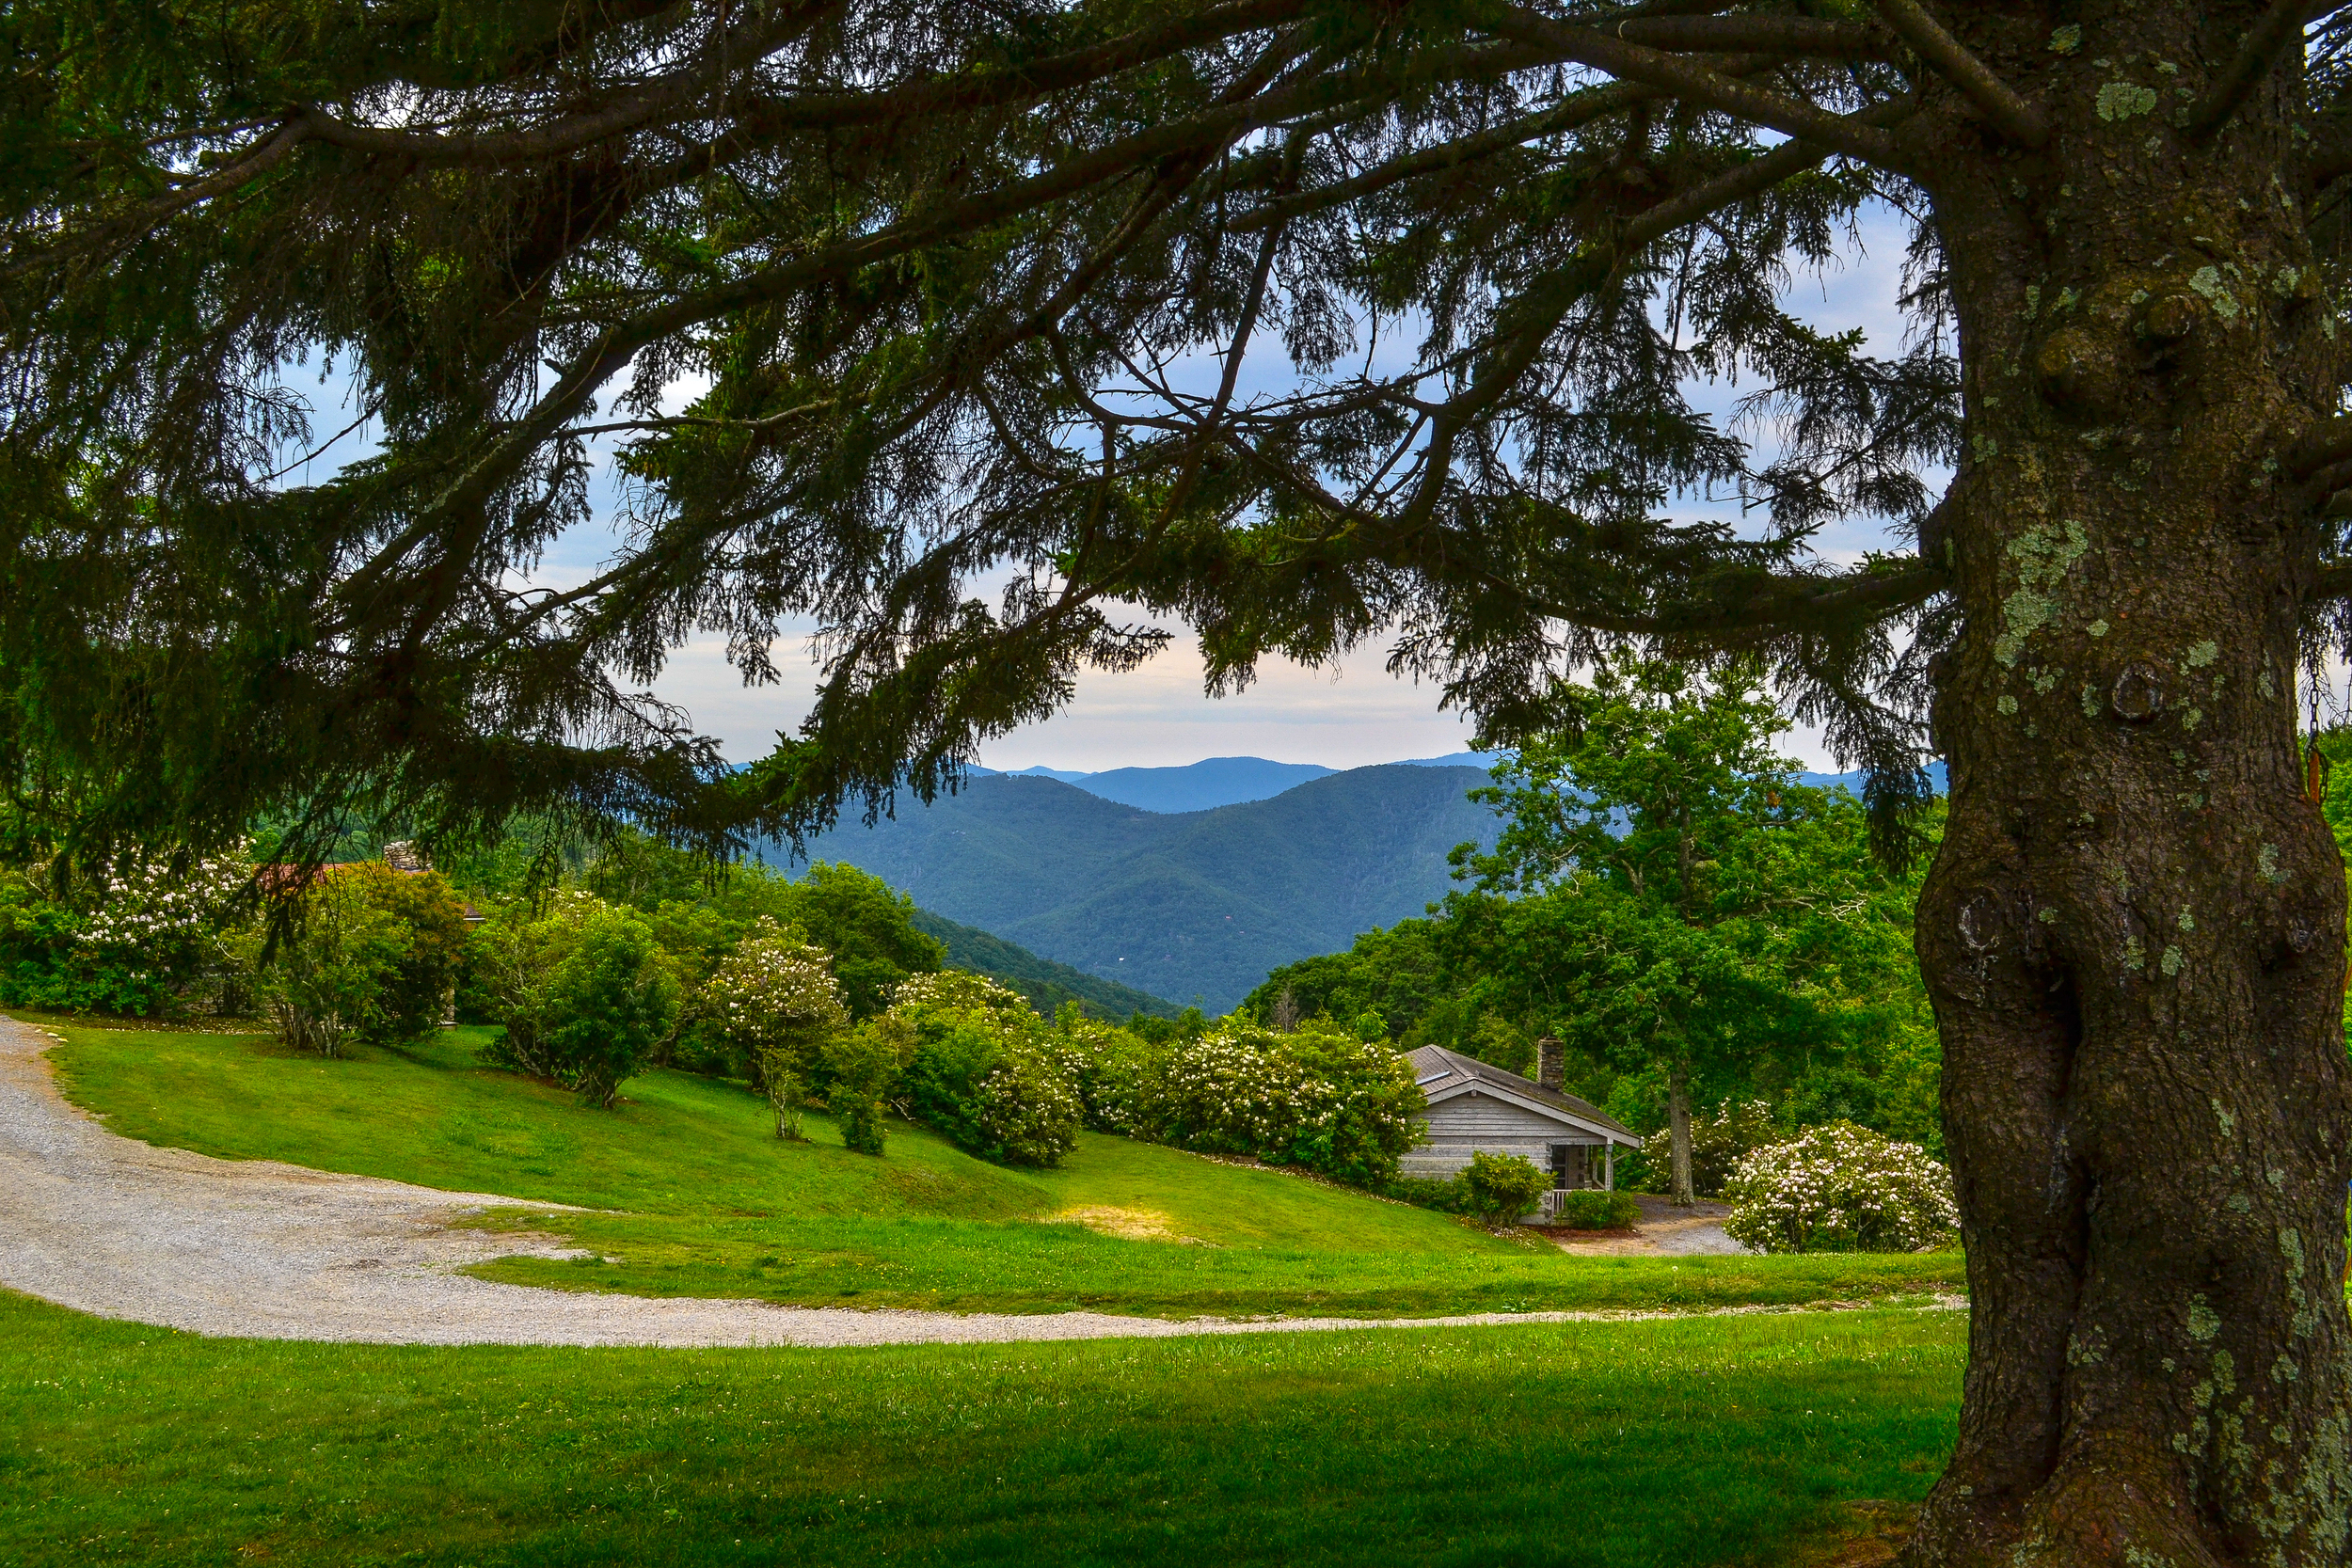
[544, 910, 677, 1107]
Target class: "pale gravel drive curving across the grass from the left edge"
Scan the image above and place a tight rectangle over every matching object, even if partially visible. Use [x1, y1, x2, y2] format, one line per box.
[0, 1018, 1929, 1345]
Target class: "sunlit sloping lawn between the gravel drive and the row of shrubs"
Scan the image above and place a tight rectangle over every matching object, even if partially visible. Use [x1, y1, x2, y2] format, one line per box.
[42, 1021, 1962, 1317]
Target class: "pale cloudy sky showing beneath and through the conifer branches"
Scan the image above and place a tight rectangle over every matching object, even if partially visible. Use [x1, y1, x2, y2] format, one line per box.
[290, 204, 1903, 771]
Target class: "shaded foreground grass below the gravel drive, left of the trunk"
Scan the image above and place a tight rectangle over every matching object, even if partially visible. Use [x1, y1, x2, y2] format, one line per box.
[0, 1291, 1966, 1568]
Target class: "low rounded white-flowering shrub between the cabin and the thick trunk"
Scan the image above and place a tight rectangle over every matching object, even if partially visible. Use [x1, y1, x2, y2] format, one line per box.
[1724, 1121, 1960, 1253]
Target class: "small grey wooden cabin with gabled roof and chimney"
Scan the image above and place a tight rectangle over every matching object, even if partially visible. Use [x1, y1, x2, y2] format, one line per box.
[1397, 1039, 1642, 1190]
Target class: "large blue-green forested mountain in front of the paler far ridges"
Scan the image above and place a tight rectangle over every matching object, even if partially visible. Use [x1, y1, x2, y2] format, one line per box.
[786, 764, 1494, 1011]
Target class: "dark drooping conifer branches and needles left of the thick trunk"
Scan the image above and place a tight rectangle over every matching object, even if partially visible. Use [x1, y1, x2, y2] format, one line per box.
[0, 0, 1960, 858]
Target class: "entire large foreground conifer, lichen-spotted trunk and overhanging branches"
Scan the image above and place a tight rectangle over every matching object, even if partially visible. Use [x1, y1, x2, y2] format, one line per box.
[0, 0, 2352, 1563]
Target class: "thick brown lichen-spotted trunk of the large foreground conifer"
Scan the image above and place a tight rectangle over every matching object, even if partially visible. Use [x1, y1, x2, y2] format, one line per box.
[1908, 5, 2352, 1568]
